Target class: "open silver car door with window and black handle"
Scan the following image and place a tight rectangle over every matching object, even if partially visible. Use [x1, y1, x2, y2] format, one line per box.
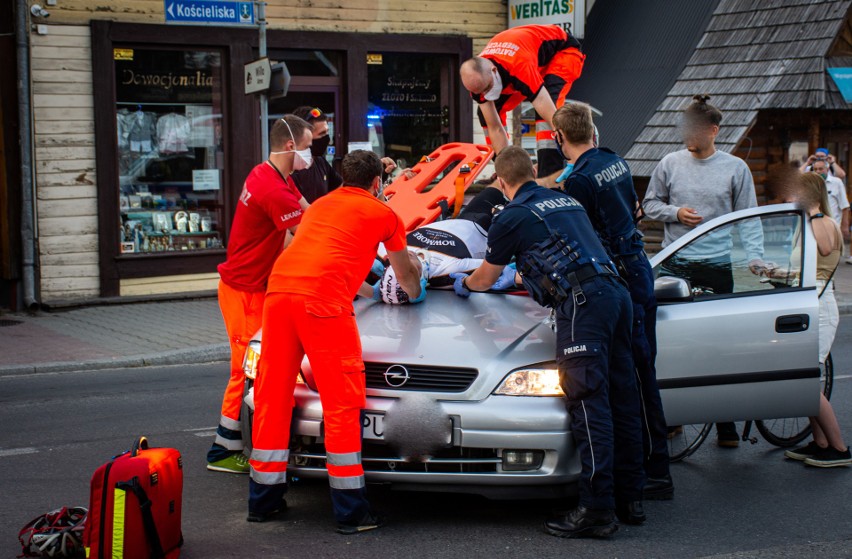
[651, 204, 820, 425]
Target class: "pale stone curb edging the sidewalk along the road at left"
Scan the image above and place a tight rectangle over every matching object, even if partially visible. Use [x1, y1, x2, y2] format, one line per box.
[0, 343, 231, 377]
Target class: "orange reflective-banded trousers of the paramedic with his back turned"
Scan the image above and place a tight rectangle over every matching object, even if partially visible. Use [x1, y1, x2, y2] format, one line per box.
[249, 293, 366, 493]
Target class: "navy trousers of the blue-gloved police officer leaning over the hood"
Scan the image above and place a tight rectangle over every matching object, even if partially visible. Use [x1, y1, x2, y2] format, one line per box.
[556, 276, 645, 510]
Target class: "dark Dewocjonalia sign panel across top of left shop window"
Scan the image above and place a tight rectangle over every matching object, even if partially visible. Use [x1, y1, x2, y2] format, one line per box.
[115, 49, 219, 104]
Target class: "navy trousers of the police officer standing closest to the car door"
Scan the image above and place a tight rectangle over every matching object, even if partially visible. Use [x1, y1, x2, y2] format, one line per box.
[624, 253, 669, 478]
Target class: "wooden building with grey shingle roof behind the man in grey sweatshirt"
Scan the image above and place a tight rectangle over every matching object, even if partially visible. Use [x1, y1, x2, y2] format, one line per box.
[625, 0, 852, 201]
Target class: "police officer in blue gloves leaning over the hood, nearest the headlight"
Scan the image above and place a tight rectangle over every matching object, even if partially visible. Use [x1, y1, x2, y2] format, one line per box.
[451, 146, 645, 537]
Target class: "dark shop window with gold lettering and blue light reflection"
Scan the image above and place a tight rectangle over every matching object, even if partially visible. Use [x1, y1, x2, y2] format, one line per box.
[367, 52, 450, 168]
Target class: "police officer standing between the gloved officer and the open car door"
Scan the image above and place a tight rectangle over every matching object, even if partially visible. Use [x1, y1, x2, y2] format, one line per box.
[553, 103, 674, 500]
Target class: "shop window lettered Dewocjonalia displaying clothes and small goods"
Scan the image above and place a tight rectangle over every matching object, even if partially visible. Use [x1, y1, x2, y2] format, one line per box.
[113, 48, 225, 254]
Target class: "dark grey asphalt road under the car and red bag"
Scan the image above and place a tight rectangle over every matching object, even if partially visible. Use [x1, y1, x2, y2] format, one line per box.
[0, 328, 852, 559]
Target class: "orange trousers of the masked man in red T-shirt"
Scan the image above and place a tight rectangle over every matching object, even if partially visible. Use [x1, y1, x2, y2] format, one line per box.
[215, 280, 266, 451]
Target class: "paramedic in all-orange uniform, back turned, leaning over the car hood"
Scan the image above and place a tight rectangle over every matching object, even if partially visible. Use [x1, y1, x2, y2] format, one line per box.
[248, 150, 426, 534]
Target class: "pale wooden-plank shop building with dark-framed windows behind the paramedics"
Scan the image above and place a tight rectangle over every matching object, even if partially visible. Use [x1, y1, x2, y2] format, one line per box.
[21, 0, 506, 305]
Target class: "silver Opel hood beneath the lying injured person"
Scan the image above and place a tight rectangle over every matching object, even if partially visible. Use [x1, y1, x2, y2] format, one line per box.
[355, 290, 555, 377]
